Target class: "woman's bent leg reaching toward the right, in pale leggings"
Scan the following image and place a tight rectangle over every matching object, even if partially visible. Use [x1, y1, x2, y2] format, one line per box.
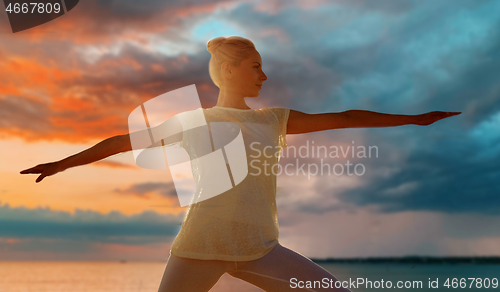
[228, 244, 350, 292]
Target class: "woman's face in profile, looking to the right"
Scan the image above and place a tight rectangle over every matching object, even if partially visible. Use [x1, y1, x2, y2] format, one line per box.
[228, 51, 267, 97]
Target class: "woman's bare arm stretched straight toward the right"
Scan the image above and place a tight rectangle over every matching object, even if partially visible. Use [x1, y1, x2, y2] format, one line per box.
[286, 110, 461, 134]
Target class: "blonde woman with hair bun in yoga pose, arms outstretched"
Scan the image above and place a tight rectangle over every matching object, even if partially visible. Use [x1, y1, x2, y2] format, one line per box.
[21, 36, 460, 292]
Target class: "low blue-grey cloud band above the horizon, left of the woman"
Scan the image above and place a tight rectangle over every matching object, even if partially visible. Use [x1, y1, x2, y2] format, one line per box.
[0, 205, 182, 244]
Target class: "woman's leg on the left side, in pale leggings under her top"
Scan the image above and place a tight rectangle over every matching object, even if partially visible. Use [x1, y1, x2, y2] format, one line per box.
[158, 254, 236, 292]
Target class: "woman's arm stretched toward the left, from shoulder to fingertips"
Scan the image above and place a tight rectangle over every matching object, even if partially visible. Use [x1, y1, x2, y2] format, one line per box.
[21, 117, 182, 183]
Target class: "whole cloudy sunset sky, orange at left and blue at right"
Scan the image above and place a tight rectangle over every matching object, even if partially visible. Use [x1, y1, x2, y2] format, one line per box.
[0, 0, 500, 261]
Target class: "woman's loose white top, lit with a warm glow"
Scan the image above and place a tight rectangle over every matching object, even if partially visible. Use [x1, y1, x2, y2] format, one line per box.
[170, 106, 290, 261]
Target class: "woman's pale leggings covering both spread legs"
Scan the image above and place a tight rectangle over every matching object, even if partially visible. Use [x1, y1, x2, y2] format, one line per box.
[158, 244, 350, 292]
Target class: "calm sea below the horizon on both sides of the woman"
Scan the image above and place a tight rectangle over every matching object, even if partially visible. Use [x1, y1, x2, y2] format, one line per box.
[0, 262, 500, 292]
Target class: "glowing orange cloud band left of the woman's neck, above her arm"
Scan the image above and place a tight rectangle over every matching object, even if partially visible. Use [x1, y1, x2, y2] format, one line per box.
[0, 52, 218, 143]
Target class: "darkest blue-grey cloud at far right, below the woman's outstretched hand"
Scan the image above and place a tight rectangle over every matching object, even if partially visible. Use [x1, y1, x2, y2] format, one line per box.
[339, 125, 500, 215]
